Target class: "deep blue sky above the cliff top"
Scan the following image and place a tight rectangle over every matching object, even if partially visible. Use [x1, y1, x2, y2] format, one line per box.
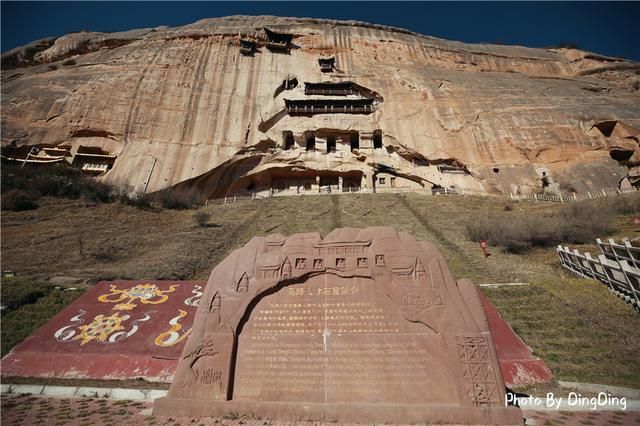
[1, 1, 640, 61]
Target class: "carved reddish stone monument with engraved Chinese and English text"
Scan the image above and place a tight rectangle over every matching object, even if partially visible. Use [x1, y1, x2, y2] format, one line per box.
[154, 227, 522, 424]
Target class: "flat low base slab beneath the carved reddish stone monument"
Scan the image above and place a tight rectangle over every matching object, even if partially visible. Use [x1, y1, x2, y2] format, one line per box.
[153, 397, 523, 425]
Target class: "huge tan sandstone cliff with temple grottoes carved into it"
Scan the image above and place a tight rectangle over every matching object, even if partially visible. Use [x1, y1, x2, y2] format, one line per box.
[2, 16, 640, 197]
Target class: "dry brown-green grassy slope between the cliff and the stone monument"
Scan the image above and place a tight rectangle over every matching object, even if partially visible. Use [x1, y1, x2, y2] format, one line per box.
[2, 194, 640, 388]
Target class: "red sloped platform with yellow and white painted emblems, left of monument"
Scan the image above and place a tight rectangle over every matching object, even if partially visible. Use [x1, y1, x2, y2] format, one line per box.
[2, 281, 205, 382]
